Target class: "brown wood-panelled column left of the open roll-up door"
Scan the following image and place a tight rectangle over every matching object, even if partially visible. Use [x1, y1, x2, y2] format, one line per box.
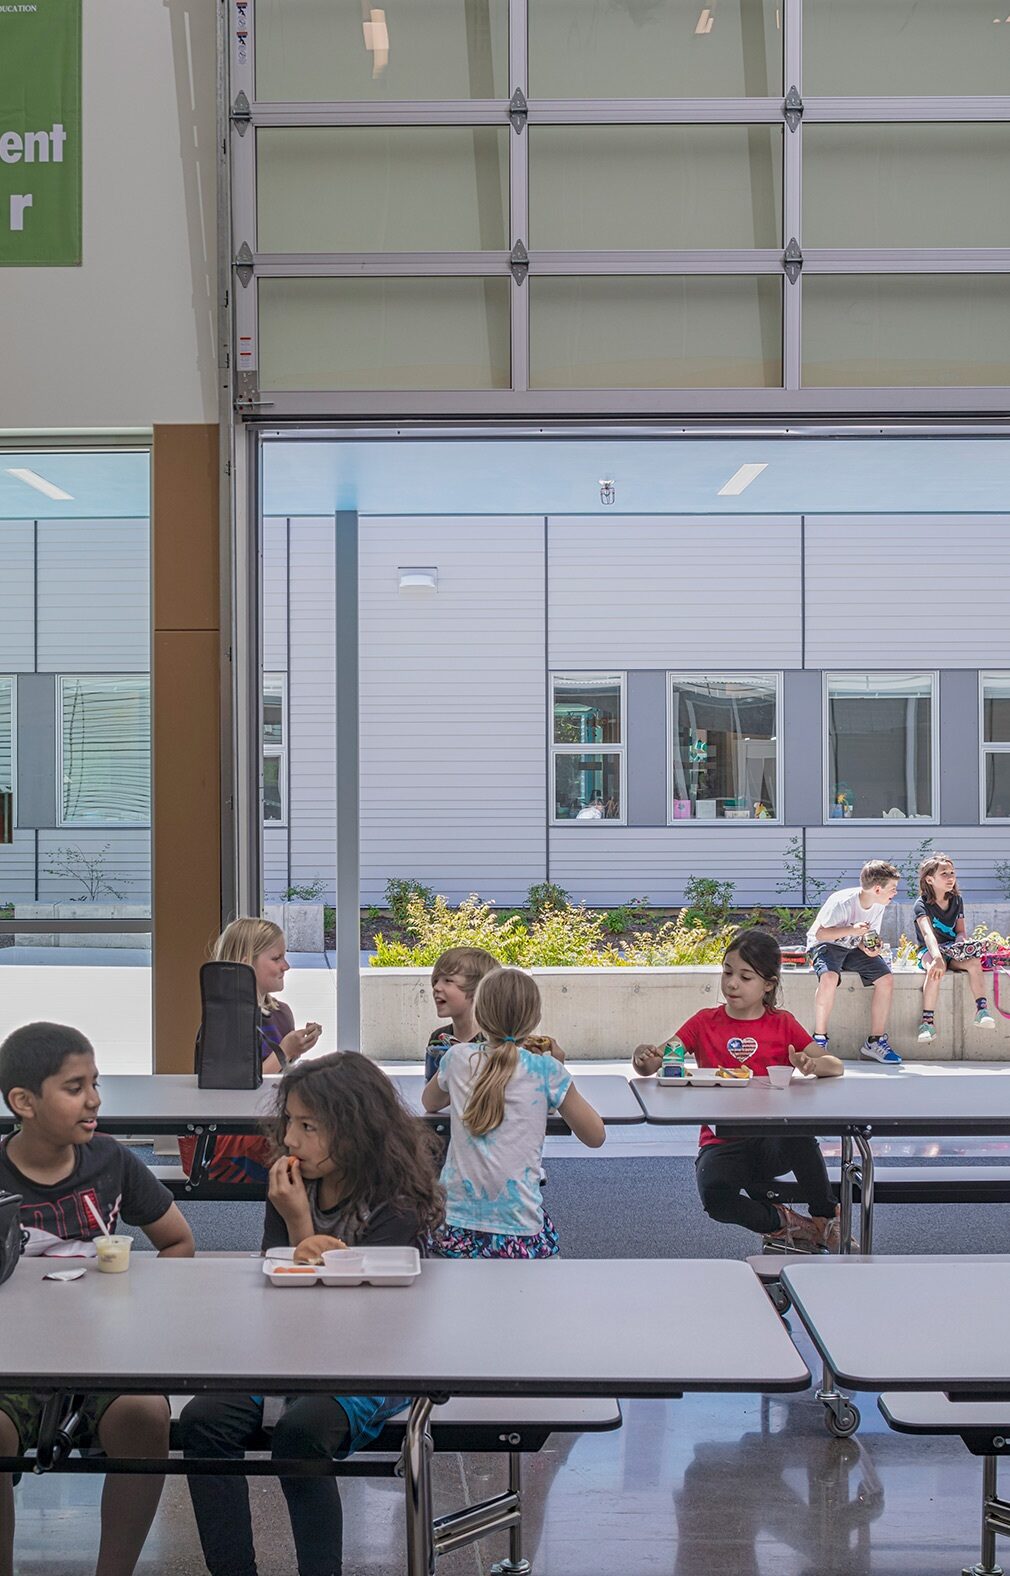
[151, 426, 221, 1073]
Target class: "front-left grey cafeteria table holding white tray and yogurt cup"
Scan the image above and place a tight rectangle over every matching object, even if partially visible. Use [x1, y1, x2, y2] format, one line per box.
[0, 1253, 810, 1576]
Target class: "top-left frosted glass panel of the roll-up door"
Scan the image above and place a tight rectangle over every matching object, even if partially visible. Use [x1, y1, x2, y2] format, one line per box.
[254, 0, 509, 102]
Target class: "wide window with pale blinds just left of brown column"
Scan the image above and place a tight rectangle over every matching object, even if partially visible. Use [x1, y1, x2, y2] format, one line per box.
[58, 675, 151, 826]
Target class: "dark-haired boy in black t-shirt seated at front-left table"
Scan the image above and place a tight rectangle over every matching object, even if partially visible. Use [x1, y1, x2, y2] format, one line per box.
[0, 1023, 194, 1576]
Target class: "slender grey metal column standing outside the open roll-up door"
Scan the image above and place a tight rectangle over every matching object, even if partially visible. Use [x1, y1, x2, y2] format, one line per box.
[334, 509, 361, 1051]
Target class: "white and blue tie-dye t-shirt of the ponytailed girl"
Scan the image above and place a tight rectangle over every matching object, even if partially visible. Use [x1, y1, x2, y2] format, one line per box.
[438, 1045, 572, 1237]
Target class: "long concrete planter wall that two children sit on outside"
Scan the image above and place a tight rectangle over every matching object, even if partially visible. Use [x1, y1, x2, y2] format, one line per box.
[361, 968, 1010, 1062]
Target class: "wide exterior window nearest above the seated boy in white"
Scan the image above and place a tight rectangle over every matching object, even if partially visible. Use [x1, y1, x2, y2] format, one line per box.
[824, 673, 936, 821]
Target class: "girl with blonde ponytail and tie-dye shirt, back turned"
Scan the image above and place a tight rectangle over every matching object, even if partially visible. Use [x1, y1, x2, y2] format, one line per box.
[422, 969, 607, 1259]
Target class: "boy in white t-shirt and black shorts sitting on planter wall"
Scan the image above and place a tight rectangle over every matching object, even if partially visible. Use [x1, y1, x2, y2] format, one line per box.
[807, 859, 901, 1067]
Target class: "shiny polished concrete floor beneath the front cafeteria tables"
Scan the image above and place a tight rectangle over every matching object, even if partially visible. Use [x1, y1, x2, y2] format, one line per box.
[3, 1332, 1010, 1576]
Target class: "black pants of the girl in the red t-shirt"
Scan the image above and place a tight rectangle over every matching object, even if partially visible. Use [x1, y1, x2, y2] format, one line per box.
[695, 1138, 835, 1236]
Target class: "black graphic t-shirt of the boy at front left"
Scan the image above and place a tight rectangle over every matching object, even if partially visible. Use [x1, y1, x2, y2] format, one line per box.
[0, 1133, 172, 1258]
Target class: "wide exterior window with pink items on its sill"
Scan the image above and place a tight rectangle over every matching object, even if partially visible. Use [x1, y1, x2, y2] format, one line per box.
[670, 673, 780, 821]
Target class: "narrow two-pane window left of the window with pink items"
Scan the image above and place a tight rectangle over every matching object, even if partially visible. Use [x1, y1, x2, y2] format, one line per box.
[551, 673, 624, 823]
